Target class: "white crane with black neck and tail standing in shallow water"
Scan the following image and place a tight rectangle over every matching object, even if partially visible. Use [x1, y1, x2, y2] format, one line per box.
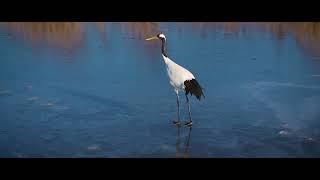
[146, 33, 205, 126]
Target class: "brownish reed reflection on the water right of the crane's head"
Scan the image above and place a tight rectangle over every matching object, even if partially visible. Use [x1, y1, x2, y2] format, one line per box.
[178, 22, 320, 56]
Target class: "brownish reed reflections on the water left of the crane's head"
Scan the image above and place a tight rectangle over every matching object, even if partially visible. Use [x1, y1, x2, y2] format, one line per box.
[0, 22, 159, 49]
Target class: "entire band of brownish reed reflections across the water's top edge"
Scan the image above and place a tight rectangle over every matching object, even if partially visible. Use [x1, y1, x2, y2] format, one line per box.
[0, 22, 320, 56]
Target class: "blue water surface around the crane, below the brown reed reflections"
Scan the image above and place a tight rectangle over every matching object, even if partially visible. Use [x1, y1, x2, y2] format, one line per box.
[0, 23, 320, 157]
